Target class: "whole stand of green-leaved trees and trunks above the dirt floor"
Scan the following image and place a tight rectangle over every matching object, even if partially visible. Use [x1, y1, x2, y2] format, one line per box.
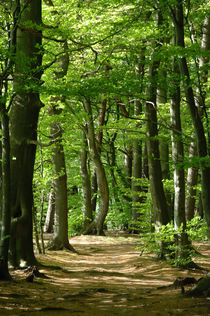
[0, 0, 210, 315]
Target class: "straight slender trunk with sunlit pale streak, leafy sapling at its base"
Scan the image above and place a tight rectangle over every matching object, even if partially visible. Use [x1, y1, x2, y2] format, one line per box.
[170, 47, 189, 264]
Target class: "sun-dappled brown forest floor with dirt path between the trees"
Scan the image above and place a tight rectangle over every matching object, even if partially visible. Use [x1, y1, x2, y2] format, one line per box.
[0, 234, 210, 316]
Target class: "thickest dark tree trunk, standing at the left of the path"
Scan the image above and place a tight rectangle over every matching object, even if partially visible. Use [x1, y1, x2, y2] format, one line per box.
[10, 0, 42, 266]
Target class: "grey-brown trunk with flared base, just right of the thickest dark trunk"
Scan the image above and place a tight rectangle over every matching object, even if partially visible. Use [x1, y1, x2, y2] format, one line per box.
[49, 42, 75, 251]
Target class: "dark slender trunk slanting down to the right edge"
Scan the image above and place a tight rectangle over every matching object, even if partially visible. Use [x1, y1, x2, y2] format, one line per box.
[172, 0, 210, 238]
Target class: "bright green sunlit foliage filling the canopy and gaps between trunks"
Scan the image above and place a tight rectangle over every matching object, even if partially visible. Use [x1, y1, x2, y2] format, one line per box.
[0, 0, 210, 253]
